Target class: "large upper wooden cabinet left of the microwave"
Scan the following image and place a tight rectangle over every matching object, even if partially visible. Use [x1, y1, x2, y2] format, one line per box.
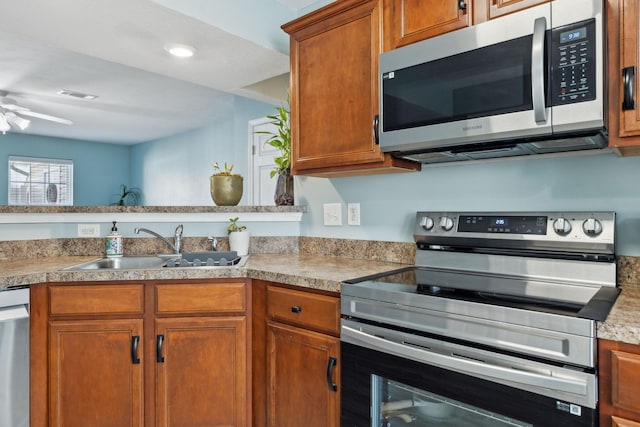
[282, 0, 420, 176]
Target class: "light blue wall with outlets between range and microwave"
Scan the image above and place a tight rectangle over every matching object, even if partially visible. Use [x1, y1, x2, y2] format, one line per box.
[296, 150, 640, 256]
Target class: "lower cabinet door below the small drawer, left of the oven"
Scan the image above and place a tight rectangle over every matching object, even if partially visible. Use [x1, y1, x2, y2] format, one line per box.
[267, 322, 340, 427]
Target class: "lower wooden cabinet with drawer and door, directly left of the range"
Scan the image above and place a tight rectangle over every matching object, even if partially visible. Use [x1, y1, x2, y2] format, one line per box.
[266, 285, 340, 427]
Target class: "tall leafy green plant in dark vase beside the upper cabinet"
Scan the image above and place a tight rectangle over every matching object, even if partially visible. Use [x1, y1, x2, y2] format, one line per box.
[256, 102, 294, 206]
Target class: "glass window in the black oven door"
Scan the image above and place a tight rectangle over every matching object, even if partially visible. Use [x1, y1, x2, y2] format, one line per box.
[371, 374, 532, 427]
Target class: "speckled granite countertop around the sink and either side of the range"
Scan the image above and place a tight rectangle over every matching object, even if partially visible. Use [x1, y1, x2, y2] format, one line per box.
[0, 253, 640, 344]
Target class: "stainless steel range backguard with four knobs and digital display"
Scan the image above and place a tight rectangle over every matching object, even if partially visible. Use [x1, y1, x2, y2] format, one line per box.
[414, 212, 615, 251]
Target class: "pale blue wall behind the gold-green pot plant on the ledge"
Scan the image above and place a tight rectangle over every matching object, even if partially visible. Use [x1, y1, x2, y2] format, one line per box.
[131, 96, 274, 206]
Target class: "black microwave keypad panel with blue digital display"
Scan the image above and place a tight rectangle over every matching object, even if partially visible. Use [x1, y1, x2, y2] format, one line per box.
[551, 19, 596, 105]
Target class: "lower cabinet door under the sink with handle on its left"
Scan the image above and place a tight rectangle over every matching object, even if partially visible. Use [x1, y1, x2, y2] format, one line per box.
[155, 316, 250, 427]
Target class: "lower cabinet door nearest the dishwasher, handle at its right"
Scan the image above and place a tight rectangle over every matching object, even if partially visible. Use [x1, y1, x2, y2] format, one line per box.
[48, 319, 145, 427]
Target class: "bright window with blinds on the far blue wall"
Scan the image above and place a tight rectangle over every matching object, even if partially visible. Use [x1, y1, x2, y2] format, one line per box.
[9, 156, 73, 206]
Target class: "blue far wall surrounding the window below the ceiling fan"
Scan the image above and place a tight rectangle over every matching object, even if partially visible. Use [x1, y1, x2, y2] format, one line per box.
[0, 133, 129, 206]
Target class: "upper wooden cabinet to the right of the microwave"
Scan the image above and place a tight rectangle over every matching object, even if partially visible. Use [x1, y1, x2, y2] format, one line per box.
[606, 0, 640, 155]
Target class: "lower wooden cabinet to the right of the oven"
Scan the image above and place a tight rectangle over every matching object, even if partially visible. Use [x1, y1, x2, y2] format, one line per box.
[598, 340, 640, 427]
